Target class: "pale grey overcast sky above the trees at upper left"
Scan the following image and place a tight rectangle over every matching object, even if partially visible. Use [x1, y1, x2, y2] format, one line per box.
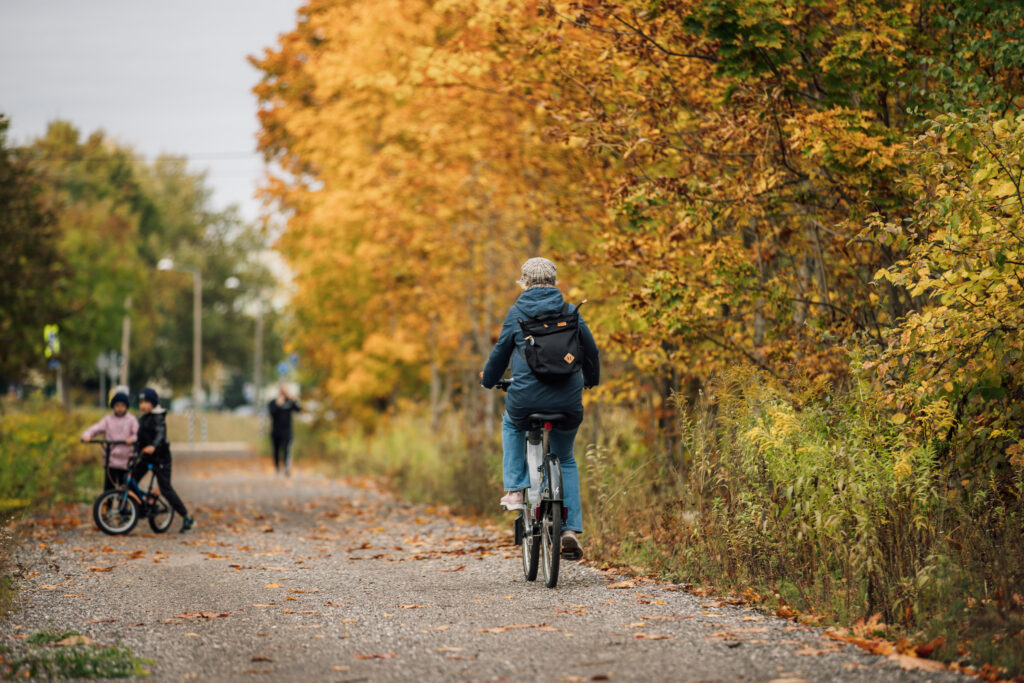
[0, 0, 302, 218]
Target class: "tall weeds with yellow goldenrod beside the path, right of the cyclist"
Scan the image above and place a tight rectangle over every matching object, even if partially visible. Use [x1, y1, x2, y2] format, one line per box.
[585, 372, 1024, 672]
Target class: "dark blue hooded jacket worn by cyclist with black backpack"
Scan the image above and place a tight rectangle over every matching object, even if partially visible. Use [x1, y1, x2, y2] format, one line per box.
[480, 287, 601, 428]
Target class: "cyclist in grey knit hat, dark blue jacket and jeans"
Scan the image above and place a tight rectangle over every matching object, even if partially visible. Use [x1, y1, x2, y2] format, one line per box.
[480, 258, 601, 559]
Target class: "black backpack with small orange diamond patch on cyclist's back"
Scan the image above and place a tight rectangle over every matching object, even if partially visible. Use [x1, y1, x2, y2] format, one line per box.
[519, 302, 586, 384]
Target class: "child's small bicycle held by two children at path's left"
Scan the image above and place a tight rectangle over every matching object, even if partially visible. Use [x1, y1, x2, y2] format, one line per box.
[90, 440, 174, 536]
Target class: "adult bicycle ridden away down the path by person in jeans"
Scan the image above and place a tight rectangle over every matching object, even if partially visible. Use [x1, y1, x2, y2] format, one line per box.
[495, 380, 568, 588]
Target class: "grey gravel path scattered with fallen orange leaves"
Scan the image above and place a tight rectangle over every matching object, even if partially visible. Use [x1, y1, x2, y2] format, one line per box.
[0, 450, 969, 682]
